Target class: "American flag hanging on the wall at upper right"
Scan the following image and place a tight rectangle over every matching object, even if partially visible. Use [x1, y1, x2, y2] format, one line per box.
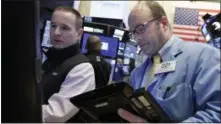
[173, 7, 220, 42]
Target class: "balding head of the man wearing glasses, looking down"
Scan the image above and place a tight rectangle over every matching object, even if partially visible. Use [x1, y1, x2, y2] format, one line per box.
[128, 1, 172, 56]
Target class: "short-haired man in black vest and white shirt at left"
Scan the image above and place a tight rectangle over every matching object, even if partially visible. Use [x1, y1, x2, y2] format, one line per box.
[42, 7, 95, 122]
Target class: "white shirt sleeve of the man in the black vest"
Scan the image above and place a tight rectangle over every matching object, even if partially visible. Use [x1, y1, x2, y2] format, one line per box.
[42, 63, 95, 122]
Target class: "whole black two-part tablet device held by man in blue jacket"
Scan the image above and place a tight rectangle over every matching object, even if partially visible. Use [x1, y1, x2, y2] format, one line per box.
[70, 82, 170, 122]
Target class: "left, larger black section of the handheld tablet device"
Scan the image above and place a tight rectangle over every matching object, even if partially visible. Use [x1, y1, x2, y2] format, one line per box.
[70, 83, 133, 122]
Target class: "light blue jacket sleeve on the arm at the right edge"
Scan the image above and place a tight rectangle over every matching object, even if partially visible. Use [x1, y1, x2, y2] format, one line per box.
[184, 47, 221, 122]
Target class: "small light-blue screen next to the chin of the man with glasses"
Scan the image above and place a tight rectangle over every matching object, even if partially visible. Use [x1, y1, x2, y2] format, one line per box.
[124, 43, 137, 59]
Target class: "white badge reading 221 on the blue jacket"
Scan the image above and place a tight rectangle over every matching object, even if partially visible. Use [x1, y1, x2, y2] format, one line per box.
[155, 60, 176, 74]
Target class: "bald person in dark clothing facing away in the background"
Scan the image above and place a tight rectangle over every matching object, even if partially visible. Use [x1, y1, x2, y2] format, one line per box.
[86, 36, 111, 88]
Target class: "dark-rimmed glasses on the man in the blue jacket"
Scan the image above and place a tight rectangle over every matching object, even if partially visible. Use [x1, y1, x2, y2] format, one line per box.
[129, 17, 160, 39]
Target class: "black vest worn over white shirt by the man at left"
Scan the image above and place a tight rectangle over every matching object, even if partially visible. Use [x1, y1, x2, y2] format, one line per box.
[42, 44, 88, 104]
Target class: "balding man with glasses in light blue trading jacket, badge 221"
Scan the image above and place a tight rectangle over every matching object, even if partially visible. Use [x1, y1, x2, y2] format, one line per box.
[118, 1, 221, 122]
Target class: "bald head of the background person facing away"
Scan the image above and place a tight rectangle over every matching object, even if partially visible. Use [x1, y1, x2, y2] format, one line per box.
[86, 35, 101, 52]
